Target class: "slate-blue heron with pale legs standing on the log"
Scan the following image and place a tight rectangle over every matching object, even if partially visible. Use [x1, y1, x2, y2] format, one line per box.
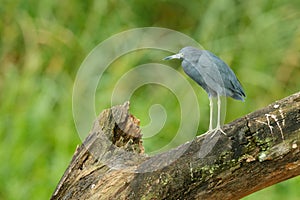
[164, 46, 246, 137]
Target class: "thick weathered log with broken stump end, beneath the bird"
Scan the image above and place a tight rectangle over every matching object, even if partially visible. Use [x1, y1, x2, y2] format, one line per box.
[52, 93, 300, 199]
